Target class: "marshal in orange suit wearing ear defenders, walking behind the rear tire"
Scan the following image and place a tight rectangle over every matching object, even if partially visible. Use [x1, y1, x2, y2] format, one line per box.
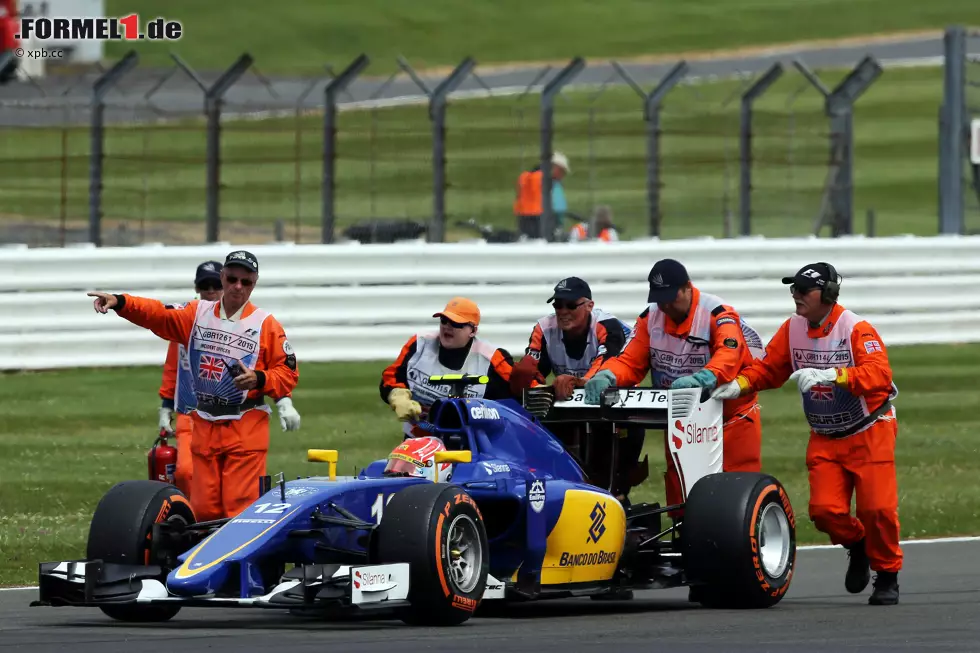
[712, 262, 903, 605]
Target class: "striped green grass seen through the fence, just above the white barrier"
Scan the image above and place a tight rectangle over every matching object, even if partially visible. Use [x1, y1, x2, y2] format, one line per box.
[0, 68, 980, 242]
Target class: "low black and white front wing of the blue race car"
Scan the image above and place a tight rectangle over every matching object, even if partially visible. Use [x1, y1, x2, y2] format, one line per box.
[35, 560, 504, 610]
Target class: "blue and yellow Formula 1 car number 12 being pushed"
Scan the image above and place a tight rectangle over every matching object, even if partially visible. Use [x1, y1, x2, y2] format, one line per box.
[35, 376, 796, 625]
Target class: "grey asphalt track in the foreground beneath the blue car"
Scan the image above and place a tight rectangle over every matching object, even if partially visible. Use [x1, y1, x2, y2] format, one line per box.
[0, 541, 980, 653]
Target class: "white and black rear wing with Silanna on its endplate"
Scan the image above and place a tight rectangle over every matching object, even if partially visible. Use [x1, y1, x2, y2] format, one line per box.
[524, 387, 724, 500]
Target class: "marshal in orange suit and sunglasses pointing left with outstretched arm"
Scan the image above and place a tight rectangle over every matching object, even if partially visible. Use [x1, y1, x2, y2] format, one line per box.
[88, 250, 299, 520]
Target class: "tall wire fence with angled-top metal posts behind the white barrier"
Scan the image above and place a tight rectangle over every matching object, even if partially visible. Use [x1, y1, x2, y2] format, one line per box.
[0, 44, 920, 246]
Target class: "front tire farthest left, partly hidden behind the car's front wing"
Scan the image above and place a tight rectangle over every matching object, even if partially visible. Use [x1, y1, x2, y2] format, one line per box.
[86, 480, 196, 622]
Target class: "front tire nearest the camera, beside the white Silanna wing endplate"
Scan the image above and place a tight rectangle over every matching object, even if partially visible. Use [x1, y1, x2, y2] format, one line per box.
[372, 483, 490, 626]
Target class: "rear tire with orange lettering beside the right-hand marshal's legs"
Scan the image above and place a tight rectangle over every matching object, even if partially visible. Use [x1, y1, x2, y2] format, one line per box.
[681, 472, 796, 608]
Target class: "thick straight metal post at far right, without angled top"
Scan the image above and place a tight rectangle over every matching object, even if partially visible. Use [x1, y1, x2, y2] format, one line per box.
[939, 25, 966, 234]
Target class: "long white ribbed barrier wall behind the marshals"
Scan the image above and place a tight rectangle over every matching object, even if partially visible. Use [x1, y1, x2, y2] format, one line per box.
[0, 237, 980, 373]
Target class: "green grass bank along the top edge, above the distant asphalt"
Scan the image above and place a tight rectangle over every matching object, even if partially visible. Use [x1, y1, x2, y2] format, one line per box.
[106, 0, 980, 73]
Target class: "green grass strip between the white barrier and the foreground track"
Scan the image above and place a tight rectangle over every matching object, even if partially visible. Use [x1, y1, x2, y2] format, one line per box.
[0, 345, 980, 585]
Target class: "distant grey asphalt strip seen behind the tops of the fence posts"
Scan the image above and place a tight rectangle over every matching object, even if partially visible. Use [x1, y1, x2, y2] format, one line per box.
[0, 33, 980, 125]
